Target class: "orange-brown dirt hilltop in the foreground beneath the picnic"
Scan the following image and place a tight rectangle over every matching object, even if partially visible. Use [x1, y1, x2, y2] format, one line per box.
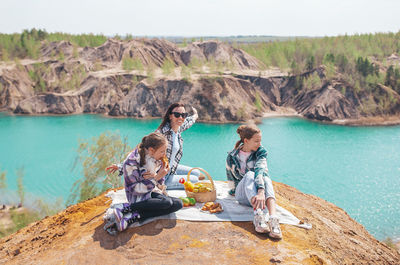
[0, 180, 400, 264]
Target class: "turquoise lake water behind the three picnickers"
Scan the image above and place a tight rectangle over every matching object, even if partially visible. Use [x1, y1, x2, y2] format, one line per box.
[0, 113, 400, 239]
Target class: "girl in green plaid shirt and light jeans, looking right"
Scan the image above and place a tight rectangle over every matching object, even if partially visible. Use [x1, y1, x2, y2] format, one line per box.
[226, 125, 282, 239]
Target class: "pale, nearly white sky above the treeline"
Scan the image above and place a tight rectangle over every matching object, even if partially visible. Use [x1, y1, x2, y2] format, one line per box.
[0, 0, 400, 37]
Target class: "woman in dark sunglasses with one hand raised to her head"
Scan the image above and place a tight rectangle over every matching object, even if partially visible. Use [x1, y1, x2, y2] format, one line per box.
[157, 103, 204, 189]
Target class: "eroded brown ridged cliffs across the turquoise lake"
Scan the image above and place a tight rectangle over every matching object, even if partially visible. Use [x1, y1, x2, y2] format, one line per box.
[0, 39, 400, 123]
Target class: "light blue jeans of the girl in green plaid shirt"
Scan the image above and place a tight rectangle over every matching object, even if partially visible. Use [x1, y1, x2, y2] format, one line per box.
[235, 171, 275, 206]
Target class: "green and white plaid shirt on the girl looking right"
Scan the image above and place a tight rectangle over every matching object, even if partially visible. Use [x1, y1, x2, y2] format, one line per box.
[226, 145, 269, 194]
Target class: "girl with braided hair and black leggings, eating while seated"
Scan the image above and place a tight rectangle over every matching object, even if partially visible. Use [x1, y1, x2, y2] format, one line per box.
[114, 133, 183, 231]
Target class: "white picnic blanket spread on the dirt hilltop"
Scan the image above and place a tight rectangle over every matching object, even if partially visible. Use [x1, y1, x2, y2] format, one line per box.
[106, 181, 312, 229]
